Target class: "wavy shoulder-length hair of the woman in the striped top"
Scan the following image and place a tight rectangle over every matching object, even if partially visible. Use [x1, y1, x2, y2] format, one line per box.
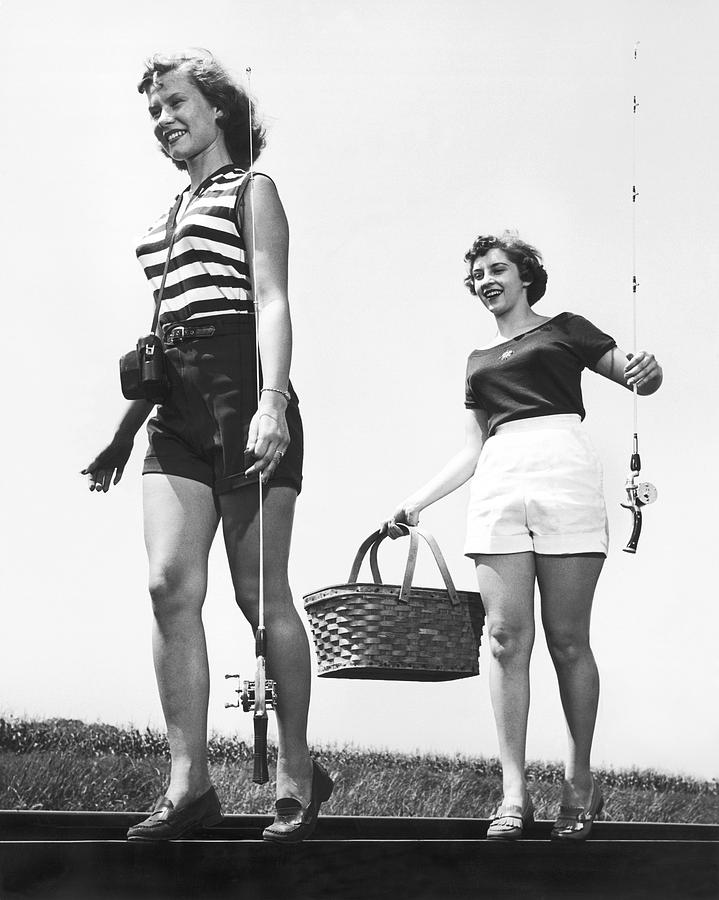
[137, 48, 265, 169]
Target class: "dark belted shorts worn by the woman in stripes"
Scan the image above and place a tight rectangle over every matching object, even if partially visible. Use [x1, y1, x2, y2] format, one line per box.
[142, 316, 303, 494]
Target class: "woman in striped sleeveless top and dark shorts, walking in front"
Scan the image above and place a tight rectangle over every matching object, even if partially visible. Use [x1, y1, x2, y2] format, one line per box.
[84, 52, 332, 841]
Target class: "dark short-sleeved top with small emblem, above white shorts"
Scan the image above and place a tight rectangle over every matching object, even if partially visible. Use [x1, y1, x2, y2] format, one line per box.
[464, 312, 616, 435]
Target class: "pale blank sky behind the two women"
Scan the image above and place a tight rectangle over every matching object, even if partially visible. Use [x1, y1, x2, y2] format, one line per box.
[0, 0, 719, 777]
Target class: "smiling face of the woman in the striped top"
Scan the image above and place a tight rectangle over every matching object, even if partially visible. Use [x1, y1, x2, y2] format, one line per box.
[146, 68, 225, 162]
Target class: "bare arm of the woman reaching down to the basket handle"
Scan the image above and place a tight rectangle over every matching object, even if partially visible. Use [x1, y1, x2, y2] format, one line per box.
[381, 409, 488, 538]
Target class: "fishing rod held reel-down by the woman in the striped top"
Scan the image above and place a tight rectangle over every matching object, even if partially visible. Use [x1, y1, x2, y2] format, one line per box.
[225, 66, 277, 784]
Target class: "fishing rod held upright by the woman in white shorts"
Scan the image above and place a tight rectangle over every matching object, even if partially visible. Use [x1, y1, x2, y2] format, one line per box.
[621, 41, 658, 553]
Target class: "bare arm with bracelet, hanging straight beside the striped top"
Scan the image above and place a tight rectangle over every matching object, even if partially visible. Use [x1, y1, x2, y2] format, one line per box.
[242, 175, 292, 481]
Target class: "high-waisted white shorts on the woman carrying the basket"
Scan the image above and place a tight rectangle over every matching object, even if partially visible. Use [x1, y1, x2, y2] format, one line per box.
[464, 415, 609, 556]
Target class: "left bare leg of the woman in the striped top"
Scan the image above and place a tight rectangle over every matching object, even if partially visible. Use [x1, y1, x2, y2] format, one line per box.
[142, 473, 218, 807]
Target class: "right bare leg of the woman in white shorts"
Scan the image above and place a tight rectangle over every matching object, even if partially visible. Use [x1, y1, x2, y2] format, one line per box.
[536, 553, 604, 807]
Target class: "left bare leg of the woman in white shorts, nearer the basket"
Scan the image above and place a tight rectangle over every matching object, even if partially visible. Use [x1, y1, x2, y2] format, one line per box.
[475, 553, 535, 806]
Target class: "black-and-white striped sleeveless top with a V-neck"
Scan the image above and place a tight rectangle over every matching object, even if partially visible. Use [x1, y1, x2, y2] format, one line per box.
[136, 165, 254, 327]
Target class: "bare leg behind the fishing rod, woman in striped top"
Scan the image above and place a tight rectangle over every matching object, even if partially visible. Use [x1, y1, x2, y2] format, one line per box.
[220, 486, 312, 806]
